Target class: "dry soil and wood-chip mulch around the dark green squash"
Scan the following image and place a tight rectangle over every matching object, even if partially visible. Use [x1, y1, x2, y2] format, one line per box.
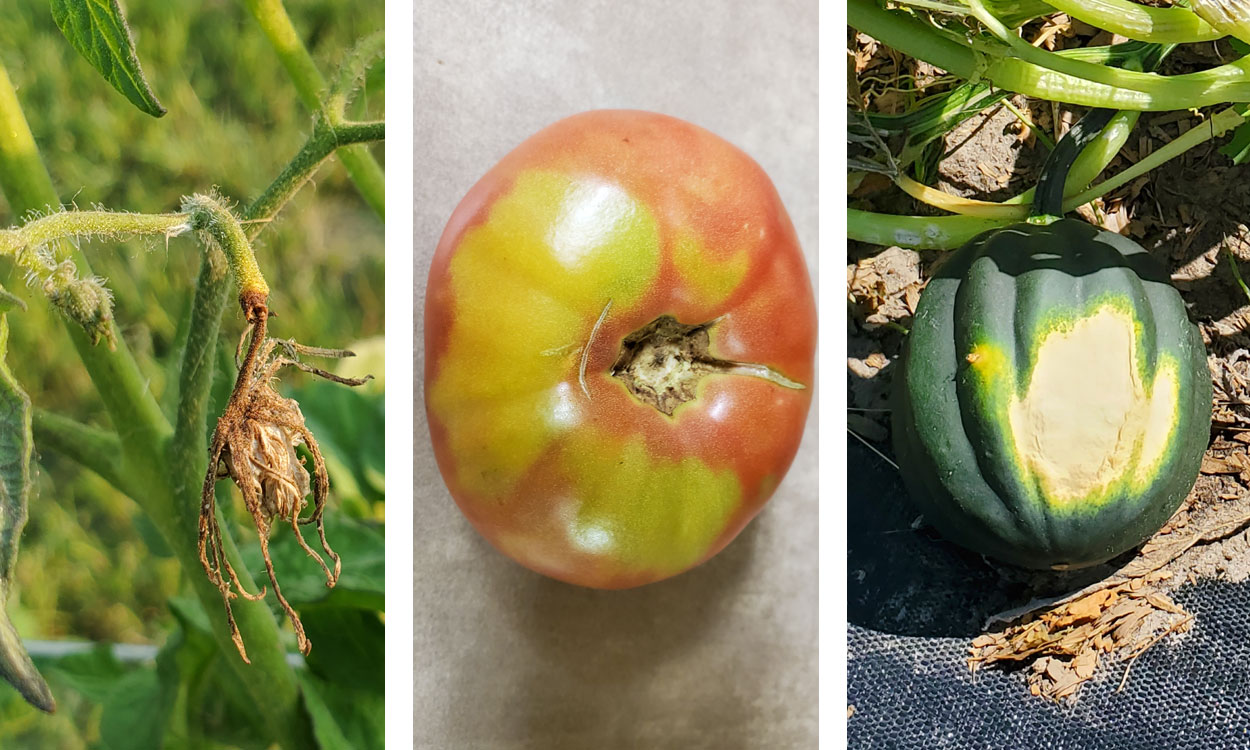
[848, 22, 1250, 700]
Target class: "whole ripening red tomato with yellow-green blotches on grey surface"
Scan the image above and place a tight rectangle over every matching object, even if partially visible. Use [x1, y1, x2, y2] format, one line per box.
[425, 110, 816, 589]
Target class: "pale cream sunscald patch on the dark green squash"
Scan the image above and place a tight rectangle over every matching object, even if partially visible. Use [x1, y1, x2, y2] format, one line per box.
[1008, 305, 1179, 504]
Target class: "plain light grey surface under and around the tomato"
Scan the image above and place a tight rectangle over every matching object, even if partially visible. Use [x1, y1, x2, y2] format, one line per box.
[413, 0, 818, 750]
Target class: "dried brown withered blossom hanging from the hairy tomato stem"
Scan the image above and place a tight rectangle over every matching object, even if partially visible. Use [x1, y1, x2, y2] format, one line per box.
[200, 295, 371, 661]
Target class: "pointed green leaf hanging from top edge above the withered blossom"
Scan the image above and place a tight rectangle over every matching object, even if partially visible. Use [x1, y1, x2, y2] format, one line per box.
[53, 0, 165, 118]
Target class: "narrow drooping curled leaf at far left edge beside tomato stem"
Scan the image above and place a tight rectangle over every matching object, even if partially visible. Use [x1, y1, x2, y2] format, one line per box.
[0, 313, 56, 711]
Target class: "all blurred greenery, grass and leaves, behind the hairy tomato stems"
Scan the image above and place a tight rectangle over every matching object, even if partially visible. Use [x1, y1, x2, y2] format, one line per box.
[0, 0, 385, 749]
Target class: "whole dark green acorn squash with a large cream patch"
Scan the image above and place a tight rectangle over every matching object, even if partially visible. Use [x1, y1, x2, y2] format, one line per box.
[894, 219, 1211, 569]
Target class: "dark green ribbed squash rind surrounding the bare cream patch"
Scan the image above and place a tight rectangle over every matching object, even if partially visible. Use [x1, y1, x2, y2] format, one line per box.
[894, 220, 1211, 569]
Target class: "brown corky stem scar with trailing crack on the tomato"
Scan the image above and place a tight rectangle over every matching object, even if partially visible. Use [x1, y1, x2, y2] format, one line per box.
[610, 315, 806, 416]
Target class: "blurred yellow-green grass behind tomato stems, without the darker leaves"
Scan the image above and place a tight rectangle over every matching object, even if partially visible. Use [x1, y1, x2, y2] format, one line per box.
[0, 0, 384, 748]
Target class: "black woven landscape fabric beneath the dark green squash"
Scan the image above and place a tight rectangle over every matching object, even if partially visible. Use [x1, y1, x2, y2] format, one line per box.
[846, 438, 1250, 750]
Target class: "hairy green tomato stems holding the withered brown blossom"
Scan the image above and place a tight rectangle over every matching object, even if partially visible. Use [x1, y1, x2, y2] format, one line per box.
[0, 24, 385, 748]
